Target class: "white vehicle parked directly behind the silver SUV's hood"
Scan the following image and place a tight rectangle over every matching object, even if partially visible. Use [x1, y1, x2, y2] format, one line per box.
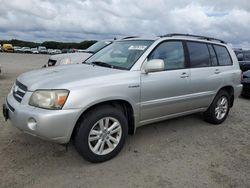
[44, 41, 112, 67]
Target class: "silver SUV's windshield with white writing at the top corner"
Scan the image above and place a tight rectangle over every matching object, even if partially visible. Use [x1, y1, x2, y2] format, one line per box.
[85, 40, 153, 69]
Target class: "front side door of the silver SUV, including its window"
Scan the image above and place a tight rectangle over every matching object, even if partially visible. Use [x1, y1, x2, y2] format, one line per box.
[140, 41, 191, 124]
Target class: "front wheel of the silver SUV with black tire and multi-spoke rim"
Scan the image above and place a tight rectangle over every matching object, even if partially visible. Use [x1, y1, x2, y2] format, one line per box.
[74, 105, 128, 163]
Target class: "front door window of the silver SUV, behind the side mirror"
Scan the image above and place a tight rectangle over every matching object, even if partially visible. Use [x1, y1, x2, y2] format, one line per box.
[148, 41, 185, 70]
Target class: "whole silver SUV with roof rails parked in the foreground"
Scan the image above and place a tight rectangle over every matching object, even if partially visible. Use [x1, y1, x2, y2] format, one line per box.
[3, 34, 242, 162]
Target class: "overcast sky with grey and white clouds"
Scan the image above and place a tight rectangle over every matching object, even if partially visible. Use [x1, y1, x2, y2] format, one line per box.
[0, 0, 250, 47]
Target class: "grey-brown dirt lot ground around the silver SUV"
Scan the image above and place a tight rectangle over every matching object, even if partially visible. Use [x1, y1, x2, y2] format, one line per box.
[0, 53, 250, 188]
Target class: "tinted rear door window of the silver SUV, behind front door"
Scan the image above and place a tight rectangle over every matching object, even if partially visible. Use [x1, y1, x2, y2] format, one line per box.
[187, 42, 210, 67]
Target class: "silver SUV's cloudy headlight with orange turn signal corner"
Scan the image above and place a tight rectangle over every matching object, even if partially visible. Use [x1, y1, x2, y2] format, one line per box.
[29, 90, 69, 110]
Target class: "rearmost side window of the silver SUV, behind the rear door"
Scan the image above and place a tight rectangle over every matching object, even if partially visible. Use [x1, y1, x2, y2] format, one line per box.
[214, 45, 232, 66]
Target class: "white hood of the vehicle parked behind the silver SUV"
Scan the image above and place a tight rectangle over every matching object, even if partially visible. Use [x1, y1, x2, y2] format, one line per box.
[50, 52, 93, 65]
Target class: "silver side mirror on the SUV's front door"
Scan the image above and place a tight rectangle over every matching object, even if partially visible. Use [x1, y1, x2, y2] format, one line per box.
[144, 59, 165, 74]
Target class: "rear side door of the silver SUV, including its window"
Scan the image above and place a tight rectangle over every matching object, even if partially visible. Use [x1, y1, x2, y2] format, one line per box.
[186, 41, 223, 108]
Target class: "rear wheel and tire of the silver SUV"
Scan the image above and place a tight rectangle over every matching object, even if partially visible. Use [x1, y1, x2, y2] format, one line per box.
[204, 90, 230, 125]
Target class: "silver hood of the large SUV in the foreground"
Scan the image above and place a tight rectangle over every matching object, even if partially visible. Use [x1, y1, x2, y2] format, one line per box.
[17, 64, 127, 91]
